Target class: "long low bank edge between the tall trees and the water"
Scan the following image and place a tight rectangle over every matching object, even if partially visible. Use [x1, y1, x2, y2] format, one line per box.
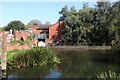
[48, 46, 112, 50]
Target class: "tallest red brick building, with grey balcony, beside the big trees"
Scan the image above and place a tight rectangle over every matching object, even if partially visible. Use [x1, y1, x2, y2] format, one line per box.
[31, 21, 64, 43]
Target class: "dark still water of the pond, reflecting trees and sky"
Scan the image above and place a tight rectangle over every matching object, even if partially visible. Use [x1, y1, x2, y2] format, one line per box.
[7, 49, 120, 78]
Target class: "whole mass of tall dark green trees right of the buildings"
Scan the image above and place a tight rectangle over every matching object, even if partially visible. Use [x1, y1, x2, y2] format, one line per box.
[59, 1, 120, 46]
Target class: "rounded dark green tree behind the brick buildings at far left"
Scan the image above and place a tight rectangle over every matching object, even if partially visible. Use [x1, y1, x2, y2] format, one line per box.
[4, 20, 25, 31]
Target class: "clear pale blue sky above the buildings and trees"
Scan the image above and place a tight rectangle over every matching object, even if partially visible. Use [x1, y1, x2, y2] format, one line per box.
[0, 0, 118, 27]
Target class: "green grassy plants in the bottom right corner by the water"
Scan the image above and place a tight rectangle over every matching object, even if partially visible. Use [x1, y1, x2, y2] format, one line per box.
[97, 71, 120, 80]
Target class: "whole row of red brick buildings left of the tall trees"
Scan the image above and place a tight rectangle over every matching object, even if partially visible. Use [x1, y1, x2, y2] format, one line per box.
[0, 21, 64, 45]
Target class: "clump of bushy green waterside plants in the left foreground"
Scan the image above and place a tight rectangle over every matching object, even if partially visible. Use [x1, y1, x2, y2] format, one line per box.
[7, 47, 60, 69]
